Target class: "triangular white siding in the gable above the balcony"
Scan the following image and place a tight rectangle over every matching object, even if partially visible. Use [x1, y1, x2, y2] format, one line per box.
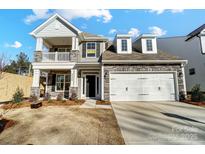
[36, 18, 76, 37]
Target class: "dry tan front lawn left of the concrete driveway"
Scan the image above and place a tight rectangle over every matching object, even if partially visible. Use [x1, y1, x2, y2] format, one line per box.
[0, 106, 124, 144]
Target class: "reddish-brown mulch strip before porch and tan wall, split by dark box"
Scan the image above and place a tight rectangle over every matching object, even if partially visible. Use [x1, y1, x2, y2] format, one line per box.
[1, 99, 85, 110]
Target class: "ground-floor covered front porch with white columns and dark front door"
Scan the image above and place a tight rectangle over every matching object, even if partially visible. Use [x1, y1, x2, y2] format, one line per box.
[31, 65, 103, 99]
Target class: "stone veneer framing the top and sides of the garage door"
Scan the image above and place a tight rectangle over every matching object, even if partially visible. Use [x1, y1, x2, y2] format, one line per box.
[104, 64, 184, 100]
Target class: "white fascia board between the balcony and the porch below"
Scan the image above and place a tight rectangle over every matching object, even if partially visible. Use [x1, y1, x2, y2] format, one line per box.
[32, 62, 76, 70]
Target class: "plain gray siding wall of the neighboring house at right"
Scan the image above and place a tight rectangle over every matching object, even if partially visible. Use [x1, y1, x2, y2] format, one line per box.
[158, 37, 205, 91]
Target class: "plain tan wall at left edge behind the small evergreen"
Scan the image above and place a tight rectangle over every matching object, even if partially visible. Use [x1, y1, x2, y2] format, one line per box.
[0, 72, 32, 102]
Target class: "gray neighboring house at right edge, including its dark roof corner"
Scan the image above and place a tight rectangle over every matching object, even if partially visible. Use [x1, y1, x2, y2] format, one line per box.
[158, 24, 205, 92]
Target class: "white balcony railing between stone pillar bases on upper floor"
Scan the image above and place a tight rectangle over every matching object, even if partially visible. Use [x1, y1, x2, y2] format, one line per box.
[42, 52, 70, 62]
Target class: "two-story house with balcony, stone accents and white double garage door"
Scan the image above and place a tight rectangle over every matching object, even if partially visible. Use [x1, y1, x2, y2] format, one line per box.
[31, 14, 187, 101]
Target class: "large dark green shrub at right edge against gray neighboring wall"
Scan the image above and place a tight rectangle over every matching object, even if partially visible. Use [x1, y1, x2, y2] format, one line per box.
[191, 84, 204, 102]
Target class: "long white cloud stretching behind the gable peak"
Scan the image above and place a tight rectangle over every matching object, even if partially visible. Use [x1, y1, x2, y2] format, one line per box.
[24, 9, 112, 24]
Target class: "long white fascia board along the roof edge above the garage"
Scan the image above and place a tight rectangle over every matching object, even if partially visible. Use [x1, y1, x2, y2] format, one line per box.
[102, 60, 188, 64]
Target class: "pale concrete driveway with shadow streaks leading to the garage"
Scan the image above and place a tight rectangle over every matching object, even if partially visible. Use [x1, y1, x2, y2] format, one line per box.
[112, 102, 205, 144]
